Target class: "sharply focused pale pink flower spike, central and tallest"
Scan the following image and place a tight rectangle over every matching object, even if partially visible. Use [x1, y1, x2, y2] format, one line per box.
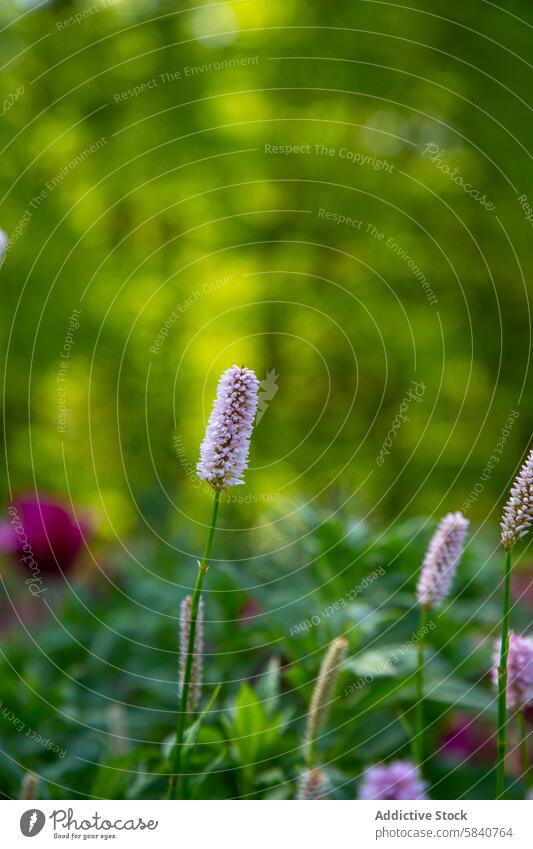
[196, 366, 259, 489]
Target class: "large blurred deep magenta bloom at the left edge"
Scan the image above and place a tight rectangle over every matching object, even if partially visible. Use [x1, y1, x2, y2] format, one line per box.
[0, 495, 90, 575]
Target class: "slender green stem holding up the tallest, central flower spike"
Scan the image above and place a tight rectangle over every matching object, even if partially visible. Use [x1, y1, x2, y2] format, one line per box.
[168, 489, 220, 799]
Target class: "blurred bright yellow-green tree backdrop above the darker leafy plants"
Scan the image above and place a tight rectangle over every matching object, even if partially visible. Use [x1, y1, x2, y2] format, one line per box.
[0, 0, 533, 534]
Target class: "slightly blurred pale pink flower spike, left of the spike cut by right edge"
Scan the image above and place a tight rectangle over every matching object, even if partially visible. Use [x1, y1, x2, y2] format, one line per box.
[417, 512, 469, 607]
